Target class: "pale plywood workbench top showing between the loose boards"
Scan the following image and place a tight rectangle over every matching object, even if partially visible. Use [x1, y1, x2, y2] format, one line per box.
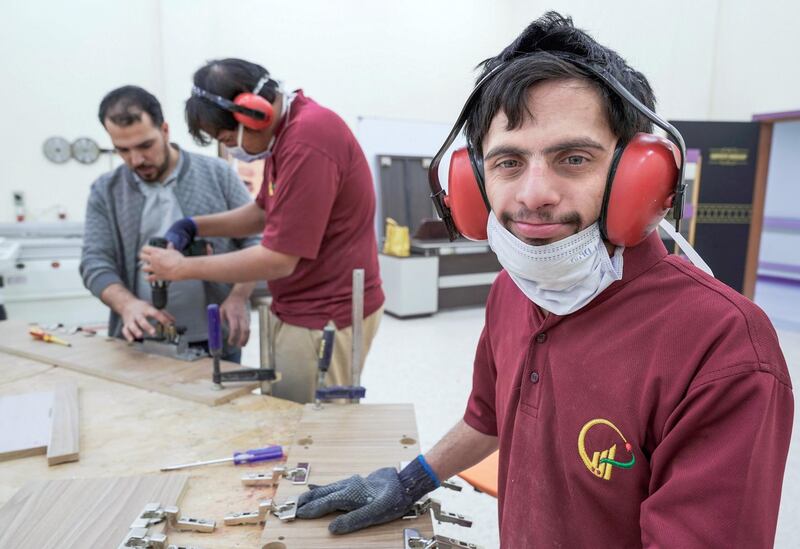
[0, 353, 302, 549]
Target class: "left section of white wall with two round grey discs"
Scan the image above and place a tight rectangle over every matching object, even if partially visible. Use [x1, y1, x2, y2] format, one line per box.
[0, 0, 161, 221]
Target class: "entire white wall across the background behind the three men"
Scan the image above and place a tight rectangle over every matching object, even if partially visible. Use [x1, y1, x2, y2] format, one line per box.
[0, 0, 800, 222]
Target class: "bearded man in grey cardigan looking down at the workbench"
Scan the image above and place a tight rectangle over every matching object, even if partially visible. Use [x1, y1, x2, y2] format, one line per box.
[80, 86, 259, 362]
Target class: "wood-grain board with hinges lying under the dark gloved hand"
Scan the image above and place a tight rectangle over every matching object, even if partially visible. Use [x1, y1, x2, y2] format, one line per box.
[261, 404, 433, 549]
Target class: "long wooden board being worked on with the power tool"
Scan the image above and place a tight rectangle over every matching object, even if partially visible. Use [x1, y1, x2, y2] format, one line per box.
[0, 320, 258, 406]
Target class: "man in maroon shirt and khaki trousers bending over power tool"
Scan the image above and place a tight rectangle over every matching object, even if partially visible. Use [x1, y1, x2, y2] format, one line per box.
[141, 59, 384, 402]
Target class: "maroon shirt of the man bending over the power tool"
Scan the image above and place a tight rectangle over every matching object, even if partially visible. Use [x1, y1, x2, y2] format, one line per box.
[256, 91, 384, 330]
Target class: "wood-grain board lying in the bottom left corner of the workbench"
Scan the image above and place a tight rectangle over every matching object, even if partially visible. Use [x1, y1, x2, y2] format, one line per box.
[0, 474, 189, 549]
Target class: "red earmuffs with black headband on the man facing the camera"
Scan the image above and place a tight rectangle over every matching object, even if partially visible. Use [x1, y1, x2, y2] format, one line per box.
[428, 51, 686, 247]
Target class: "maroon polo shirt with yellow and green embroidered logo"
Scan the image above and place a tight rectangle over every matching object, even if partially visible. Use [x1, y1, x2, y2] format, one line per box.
[464, 233, 793, 549]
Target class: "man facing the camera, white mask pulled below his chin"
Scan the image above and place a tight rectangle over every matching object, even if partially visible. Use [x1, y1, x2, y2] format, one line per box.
[290, 12, 793, 549]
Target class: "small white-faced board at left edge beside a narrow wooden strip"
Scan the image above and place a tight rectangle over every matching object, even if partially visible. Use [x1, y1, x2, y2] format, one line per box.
[0, 391, 53, 462]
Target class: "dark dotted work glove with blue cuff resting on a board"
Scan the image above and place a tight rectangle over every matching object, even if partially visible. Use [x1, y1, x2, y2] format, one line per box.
[297, 456, 440, 534]
